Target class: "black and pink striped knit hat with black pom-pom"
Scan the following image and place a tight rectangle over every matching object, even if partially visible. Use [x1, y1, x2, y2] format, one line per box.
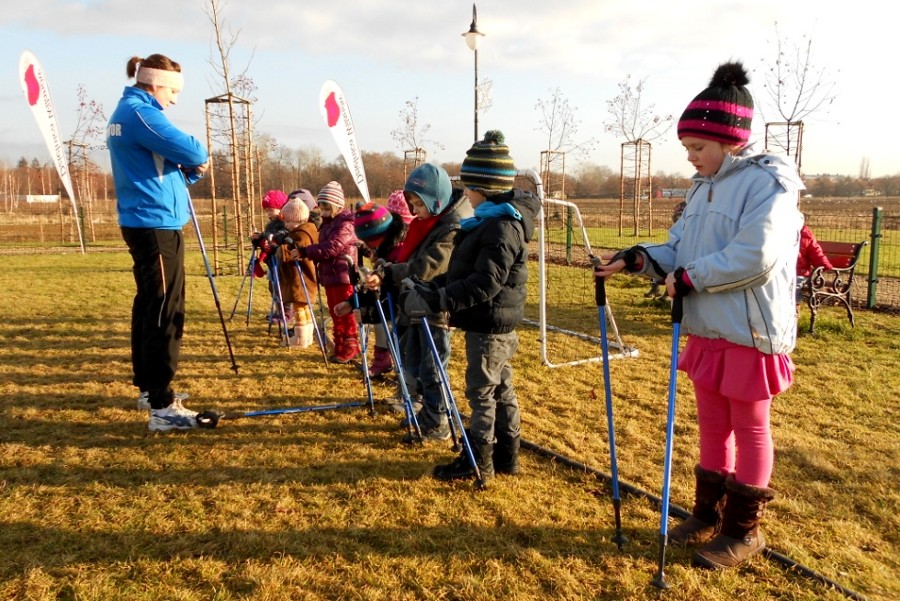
[678, 62, 753, 146]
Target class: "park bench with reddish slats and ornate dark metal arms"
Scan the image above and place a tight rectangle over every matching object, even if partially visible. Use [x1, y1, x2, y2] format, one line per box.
[803, 240, 866, 332]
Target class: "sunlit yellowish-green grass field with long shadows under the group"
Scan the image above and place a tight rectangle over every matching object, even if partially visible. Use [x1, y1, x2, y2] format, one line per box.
[0, 253, 900, 601]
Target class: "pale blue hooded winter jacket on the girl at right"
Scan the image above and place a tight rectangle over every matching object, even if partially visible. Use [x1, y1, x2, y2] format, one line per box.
[641, 153, 805, 354]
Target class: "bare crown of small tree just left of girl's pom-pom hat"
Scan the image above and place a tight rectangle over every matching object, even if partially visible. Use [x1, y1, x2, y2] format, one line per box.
[603, 75, 675, 142]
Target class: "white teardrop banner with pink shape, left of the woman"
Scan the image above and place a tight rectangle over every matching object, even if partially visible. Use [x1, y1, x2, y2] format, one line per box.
[19, 50, 84, 253]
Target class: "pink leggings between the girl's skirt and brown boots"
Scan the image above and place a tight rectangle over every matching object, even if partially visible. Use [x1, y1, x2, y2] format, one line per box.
[694, 384, 775, 487]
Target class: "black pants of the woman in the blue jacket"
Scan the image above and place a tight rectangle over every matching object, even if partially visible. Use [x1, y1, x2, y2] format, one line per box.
[122, 227, 184, 409]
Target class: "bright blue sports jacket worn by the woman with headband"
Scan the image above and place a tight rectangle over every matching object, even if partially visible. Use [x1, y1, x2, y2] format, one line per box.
[106, 86, 209, 230]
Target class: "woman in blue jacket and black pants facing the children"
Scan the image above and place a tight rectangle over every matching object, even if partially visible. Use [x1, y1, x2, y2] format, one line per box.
[106, 54, 209, 431]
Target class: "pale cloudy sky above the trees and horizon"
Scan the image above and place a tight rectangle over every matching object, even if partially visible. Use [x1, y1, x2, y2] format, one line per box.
[0, 0, 900, 179]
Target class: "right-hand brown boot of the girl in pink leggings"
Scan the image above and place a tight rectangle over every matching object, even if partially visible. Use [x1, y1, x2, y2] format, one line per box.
[694, 476, 775, 570]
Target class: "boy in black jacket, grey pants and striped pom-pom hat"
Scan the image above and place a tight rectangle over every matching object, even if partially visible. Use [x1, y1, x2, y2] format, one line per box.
[404, 131, 540, 480]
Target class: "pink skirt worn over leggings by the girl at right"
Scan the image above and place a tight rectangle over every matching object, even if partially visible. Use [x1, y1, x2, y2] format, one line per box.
[678, 336, 794, 401]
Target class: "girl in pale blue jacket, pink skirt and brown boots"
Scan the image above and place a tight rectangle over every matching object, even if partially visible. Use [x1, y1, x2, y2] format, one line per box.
[596, 63, 804, 568]
